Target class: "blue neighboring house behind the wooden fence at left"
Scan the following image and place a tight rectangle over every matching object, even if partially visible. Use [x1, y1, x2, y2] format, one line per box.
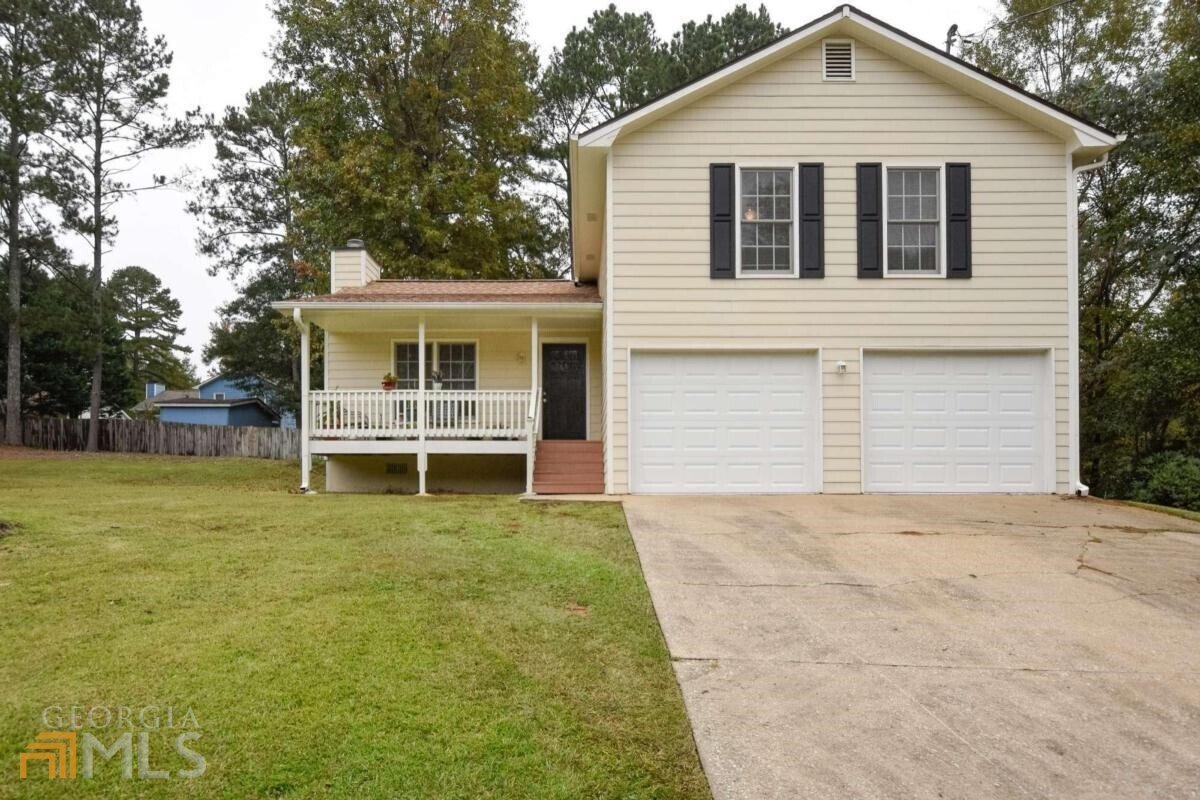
[154, 374, 295, 428]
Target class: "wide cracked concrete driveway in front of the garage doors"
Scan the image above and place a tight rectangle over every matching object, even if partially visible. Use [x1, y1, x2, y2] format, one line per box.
[625, 495, 1200, 800]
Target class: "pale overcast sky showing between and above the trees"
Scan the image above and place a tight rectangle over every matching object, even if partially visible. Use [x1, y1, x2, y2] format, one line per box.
[100, 0, 994, 375]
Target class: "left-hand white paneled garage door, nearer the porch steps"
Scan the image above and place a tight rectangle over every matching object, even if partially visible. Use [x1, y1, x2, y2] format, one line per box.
[630, 353, 820, 494]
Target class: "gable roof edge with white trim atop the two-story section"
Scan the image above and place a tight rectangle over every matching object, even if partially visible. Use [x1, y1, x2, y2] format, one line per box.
[577, 4, 1116, 146]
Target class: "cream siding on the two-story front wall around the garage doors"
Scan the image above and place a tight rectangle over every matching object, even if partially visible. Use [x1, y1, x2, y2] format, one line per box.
[607, 38, 1068, 493]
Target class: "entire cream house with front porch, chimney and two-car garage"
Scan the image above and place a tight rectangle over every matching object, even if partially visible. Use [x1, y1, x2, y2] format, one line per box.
[277, 6, 1118, 493]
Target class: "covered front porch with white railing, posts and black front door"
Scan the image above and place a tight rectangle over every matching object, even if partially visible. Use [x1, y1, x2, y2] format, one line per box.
[280, 281, 602, 494]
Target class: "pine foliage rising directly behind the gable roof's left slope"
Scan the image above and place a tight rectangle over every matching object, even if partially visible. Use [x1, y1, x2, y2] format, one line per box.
[536, 5, 785, 264]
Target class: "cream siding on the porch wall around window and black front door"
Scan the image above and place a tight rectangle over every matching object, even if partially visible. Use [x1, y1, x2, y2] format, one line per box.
[325, 326, 602, 439]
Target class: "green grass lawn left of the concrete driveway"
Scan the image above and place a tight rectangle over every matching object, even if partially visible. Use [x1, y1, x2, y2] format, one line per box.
[0, 456, 708, 800]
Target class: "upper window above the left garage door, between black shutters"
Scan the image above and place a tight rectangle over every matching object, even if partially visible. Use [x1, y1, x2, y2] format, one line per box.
[738, 168, 796, 275]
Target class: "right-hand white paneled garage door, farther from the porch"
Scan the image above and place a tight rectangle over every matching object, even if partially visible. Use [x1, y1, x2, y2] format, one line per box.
[863, 353, 1054, 493]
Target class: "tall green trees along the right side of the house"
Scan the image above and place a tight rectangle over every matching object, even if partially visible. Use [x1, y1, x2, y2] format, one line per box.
[966, 0, 1200, 497]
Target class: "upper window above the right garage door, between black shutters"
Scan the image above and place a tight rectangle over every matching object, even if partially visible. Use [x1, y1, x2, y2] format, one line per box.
[886, 167, 942, 275]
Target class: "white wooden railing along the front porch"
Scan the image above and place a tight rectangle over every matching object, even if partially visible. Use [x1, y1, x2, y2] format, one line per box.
[307, 389, 533, 439]
